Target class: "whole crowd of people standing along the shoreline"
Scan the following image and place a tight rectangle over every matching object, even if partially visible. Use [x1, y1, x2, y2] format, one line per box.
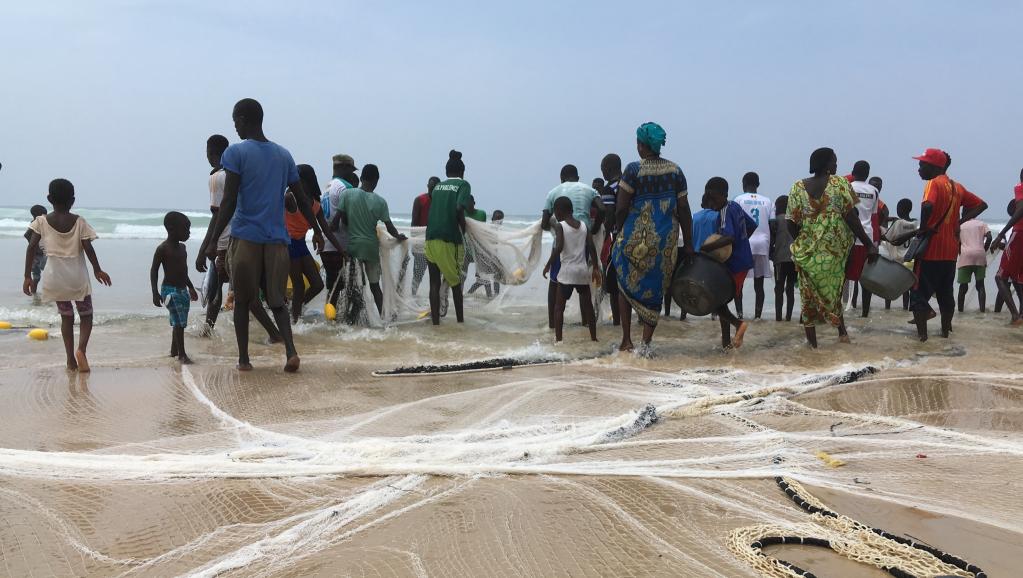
[24, 98, 1023, 371]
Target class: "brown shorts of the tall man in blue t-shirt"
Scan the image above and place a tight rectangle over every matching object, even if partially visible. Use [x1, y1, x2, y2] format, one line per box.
[227, 237, 292, 309]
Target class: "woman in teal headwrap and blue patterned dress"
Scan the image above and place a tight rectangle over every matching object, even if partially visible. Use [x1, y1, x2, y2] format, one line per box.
[611, 123, 693, 351]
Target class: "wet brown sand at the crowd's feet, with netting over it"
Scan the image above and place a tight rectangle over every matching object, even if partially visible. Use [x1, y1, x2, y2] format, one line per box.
[0, 310, 1023, 577]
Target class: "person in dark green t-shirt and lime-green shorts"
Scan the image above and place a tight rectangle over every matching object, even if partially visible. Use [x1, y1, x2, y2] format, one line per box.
[426, 150, 471, 325]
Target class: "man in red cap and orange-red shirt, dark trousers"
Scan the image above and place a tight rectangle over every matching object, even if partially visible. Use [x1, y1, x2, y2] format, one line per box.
[909, 148, 987, 342]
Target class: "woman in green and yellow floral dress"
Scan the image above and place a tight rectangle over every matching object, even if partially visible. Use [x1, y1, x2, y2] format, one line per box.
[788, 148, 878, 348]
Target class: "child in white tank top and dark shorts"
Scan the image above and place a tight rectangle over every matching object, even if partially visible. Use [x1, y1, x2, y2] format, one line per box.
[543, 196, 601, 342]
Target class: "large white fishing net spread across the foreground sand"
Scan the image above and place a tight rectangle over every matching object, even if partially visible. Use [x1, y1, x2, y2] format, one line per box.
[0, 348, 1023, 578]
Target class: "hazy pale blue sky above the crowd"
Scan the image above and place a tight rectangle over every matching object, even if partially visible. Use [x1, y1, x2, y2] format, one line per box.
[0, 0, 1023, 216]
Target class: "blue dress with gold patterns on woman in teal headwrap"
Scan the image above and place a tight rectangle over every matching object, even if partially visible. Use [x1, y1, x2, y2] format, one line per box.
[611, 159, 687, 326]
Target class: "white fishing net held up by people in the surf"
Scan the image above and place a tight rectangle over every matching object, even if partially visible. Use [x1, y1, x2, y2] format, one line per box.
[337, 220, 542, 326]
